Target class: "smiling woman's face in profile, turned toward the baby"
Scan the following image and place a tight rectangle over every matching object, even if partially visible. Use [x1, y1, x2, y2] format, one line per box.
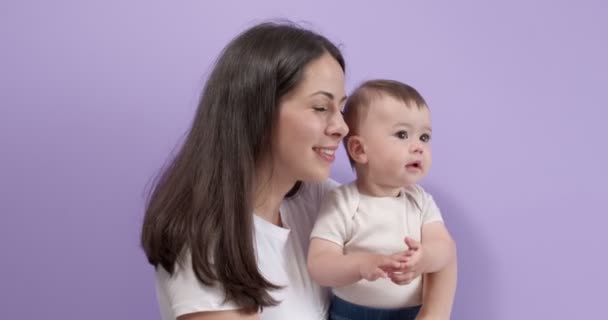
[272, 53, 348, 182]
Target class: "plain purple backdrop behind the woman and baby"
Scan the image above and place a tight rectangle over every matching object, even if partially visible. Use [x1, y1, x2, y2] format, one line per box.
[0, 0, 608, 320]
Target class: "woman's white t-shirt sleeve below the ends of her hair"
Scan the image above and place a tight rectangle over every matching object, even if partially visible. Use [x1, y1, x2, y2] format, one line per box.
[156, 255, 238, 318]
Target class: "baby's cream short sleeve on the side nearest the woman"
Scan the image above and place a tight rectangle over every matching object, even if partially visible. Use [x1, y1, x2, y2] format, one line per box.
[310, 187, 351, 247]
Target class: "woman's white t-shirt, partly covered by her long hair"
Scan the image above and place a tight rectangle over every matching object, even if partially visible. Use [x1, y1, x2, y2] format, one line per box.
[156, 180, 337, 320]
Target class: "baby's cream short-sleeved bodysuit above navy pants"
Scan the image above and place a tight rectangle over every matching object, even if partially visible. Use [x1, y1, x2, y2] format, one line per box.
[311, 182, 442, 308]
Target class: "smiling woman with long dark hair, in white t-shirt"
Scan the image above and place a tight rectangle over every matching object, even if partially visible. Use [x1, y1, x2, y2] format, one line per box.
[142, 23, 456, 320]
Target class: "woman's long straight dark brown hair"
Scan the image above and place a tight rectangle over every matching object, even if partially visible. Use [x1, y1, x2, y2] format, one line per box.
[141, 22, 344, 312]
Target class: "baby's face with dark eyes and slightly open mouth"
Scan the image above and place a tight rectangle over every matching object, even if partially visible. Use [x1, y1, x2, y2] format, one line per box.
[359, 95, 431, 187]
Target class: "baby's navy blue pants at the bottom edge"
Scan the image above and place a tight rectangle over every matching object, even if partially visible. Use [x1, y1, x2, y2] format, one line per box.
[329, 295, 420, 320]
